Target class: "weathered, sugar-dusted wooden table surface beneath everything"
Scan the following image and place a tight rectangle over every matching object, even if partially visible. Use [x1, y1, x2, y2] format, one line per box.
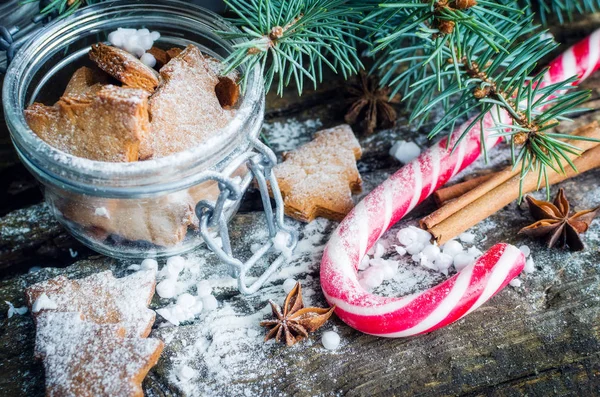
[0, 17, 600, 396]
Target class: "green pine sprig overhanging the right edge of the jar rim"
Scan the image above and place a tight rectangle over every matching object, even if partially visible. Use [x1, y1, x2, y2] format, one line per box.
[220, 0, 364, 95]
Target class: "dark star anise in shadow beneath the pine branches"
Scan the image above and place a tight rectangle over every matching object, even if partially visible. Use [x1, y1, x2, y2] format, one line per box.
[344, 72, 397, 134]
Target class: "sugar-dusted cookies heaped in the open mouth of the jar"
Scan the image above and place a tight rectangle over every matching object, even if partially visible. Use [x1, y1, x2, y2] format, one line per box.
[25, 43, 239, 162]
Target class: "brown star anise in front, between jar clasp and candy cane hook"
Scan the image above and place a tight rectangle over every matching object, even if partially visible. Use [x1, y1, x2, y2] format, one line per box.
[260, 283, 335, 346]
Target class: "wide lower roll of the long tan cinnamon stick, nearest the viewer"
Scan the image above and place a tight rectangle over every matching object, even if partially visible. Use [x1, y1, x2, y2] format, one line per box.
[428, 145, 600, 245]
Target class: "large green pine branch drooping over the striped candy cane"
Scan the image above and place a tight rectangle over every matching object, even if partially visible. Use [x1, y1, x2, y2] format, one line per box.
[365, 0, 589, 197]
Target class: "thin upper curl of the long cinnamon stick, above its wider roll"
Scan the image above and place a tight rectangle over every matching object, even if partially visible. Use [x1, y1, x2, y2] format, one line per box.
[420, 121, 600, 229]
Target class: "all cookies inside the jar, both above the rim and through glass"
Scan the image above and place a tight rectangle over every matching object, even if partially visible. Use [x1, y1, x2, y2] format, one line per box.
[24, 28, 248, 251]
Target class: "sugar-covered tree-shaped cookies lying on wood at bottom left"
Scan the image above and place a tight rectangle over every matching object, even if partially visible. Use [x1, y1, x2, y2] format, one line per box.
[26, 271, 163, 397]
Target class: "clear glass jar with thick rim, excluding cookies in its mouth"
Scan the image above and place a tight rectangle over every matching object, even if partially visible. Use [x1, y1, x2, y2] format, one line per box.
[3, 0, 264, 258]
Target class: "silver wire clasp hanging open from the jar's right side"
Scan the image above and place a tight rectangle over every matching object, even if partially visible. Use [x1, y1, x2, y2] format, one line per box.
[196, 138, 298, 294]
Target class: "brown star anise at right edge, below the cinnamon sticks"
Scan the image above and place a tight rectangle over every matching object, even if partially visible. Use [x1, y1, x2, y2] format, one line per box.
[519, 189, 600, 251]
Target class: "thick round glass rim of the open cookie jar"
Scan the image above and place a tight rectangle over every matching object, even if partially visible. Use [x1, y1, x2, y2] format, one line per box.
[2, 0, 264, 193]
